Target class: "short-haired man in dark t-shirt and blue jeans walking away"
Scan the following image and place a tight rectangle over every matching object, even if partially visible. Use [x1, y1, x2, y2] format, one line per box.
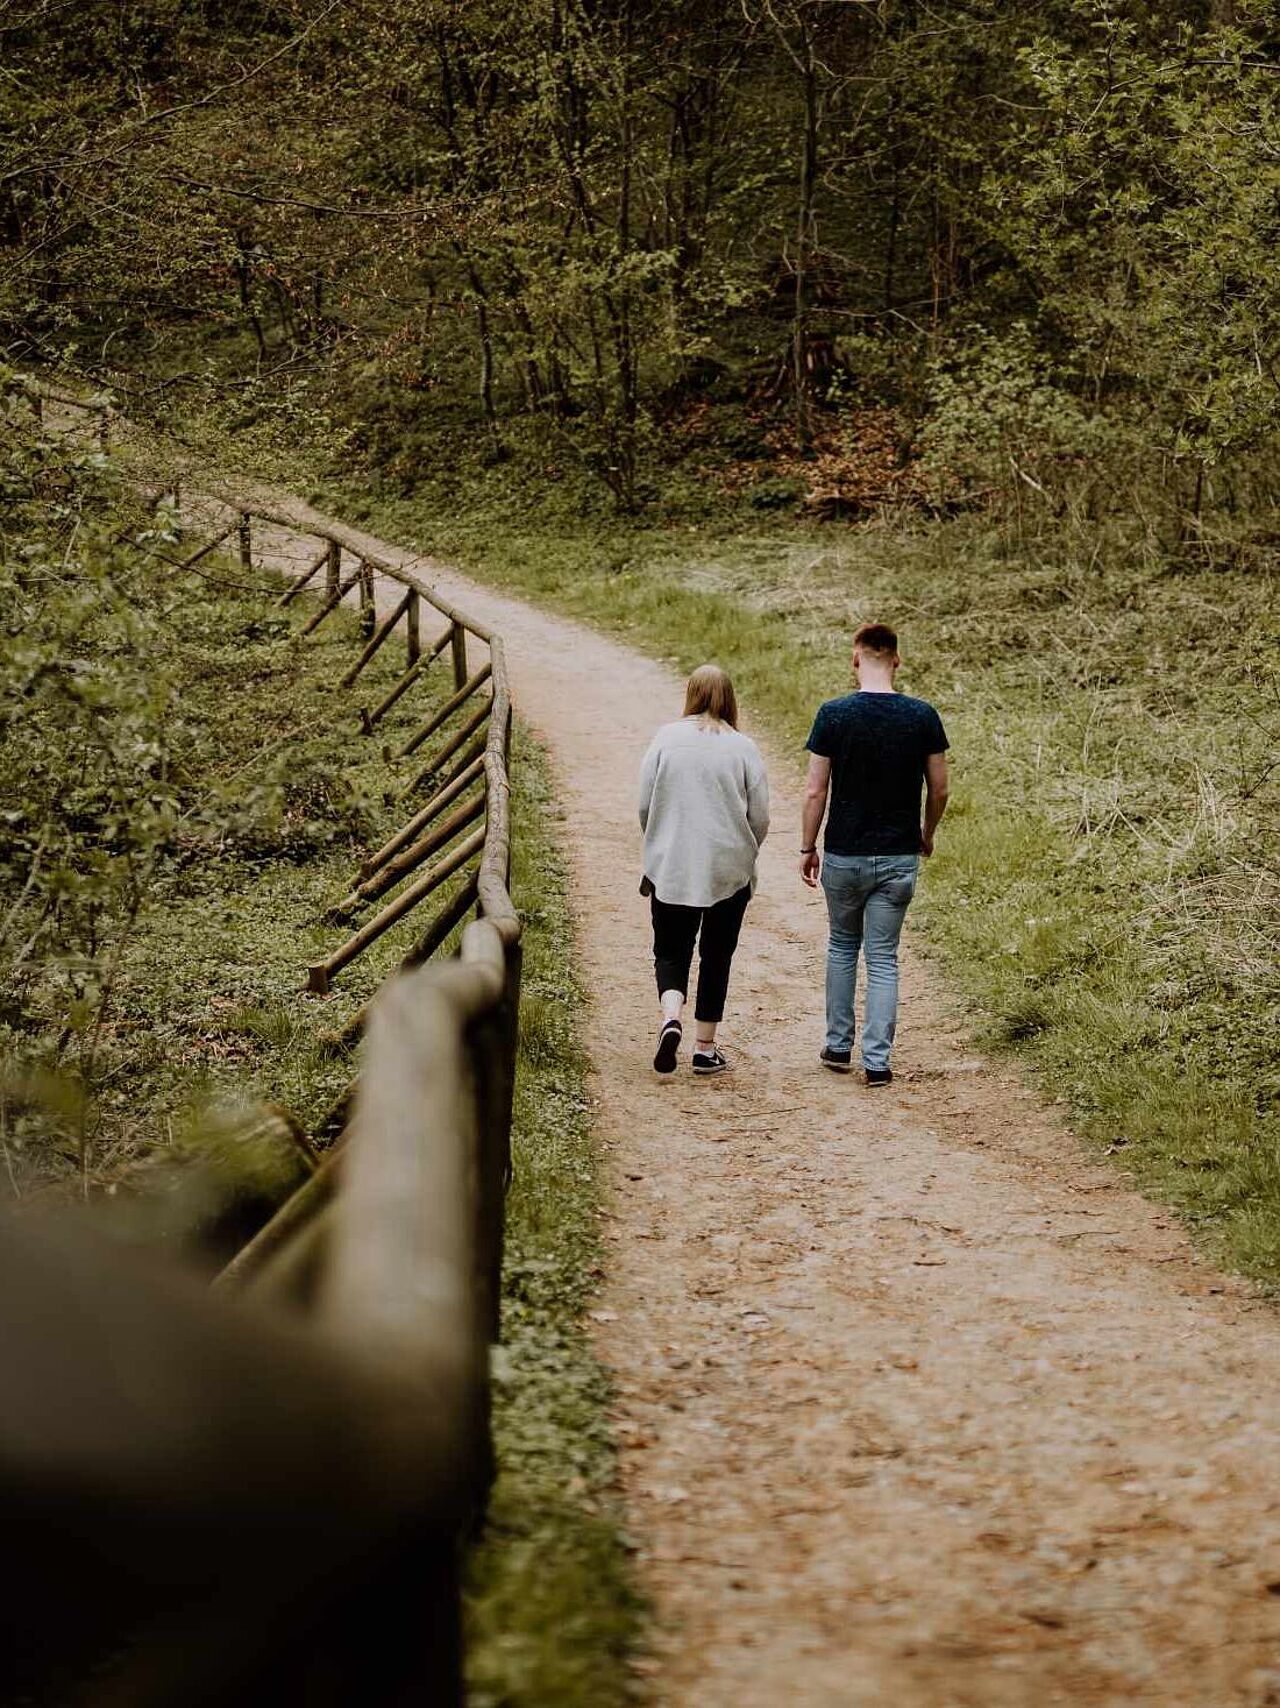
[800, 623, 948, 1085]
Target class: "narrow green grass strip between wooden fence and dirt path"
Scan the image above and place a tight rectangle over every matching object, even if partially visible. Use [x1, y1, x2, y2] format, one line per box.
[468, 731, 641, 1708]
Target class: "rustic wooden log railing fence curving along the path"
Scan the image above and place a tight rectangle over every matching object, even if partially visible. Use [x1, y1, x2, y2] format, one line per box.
[0, 387, 520, 1708]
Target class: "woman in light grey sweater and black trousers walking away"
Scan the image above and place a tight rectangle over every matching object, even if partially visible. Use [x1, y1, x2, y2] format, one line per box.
[639, 664, 769, 1074]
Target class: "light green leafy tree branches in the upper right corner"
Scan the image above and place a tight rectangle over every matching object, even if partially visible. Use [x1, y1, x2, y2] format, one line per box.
[1000, 0, 1280, 463]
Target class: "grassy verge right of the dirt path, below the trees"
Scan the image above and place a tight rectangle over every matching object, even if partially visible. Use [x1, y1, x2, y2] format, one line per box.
[331, 468, 1280, 1284]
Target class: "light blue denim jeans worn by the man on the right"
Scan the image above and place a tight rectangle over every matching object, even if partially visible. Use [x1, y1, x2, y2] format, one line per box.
[822, 854, 919, 1071]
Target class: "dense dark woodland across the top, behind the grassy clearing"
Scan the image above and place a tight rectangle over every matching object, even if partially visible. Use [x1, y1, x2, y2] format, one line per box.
[0, 0, 1280, 529]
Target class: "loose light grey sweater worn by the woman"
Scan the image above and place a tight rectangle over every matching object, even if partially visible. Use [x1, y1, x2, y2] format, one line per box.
[639, 717, 769, 907]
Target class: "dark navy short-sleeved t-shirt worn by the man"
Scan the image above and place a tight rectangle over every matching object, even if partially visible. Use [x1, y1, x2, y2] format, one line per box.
[805, 693, 950, 854]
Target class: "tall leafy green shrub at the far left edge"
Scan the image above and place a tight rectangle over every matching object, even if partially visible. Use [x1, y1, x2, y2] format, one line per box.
[0, 389, 181, 1181]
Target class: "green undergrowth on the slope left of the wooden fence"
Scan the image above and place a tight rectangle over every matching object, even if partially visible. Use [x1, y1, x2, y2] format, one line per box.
[0, 388, 468, 1194]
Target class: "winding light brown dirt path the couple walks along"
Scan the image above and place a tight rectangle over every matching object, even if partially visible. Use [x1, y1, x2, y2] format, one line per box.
[220, 488, 1280, 1708]
